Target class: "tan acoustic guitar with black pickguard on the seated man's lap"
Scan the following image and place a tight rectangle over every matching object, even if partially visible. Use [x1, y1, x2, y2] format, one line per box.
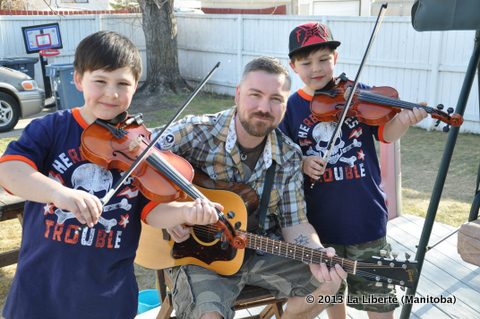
[135, 175, 417, 288]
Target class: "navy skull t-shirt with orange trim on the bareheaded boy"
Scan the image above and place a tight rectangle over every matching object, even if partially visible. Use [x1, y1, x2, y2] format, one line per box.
[1, 109, 148, 319]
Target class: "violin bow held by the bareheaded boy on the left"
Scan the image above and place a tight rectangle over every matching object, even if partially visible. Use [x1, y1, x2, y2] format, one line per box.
[100, 62, 220, 205]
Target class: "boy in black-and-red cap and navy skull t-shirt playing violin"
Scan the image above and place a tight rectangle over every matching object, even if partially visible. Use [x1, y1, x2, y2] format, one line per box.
[280, 22, 427, 318]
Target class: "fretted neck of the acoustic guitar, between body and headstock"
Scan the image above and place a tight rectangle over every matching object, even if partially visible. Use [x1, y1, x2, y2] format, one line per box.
[241, 232, 357, 274]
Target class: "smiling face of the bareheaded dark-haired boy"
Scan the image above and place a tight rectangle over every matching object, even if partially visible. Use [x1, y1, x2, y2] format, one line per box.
[74, 67, 138, 124]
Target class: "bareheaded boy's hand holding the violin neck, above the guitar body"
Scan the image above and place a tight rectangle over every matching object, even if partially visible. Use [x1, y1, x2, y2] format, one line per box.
[183, 198, 223, 225]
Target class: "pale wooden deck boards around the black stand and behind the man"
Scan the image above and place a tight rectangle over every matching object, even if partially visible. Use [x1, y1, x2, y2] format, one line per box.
[137, 215, 480, 319]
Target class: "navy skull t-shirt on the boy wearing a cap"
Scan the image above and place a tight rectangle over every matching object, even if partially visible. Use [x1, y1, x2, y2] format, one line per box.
[280, 90, 388, 245]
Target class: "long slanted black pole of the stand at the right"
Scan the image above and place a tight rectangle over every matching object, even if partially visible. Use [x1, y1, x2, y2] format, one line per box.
[400, 30, 480, 319]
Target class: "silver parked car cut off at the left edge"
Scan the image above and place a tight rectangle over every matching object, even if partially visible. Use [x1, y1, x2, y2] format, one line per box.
[0, 67, 45, 132]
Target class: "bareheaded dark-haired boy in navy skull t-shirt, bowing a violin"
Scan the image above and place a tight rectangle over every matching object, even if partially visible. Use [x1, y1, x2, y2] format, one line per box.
[0, 31, 221, 319]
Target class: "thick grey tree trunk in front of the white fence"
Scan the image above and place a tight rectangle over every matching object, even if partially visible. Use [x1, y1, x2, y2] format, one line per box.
[138, 0, 188, 93]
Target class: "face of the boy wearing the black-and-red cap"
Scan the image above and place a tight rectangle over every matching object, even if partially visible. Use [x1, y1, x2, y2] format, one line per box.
[290, 48, 337, 95]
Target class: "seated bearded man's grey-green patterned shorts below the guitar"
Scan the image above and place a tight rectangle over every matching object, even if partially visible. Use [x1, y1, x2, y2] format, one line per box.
[172, 250, 319, 319]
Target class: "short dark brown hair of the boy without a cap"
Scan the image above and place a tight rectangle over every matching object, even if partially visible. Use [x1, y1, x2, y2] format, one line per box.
[73, 31, 142, 81]
